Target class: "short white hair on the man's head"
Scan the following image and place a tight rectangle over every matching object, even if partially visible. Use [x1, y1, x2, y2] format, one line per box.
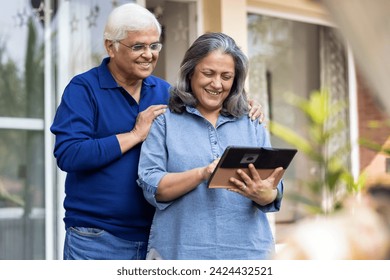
[104, 3, 161, 50]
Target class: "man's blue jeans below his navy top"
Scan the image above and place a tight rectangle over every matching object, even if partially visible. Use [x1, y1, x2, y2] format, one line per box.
[64, 227, 147, 260]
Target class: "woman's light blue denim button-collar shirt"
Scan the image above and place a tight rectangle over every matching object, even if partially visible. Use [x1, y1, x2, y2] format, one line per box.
[138, 107, 283, 260]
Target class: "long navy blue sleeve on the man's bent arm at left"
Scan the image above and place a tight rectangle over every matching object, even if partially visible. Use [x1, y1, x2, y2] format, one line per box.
[50, 79, 122, 172]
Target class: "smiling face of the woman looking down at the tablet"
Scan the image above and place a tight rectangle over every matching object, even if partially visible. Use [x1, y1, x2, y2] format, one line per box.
[191, 50, 235, 115]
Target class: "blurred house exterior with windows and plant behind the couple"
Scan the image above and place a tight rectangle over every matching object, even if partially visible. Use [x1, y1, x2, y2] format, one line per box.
[0, 0, 390, 260]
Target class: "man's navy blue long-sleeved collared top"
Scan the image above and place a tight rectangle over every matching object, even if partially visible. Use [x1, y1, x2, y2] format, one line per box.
[51, 58, 170, 241]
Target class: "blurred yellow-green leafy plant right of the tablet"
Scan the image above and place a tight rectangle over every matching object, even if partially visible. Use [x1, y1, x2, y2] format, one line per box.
[269, 90, 364, 214]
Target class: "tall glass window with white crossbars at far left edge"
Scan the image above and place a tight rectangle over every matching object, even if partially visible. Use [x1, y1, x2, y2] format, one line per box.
[0, 1, 45, 259]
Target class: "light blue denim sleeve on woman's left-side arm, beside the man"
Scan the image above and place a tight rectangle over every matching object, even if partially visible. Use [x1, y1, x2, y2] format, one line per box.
[137, 115, 172, 210]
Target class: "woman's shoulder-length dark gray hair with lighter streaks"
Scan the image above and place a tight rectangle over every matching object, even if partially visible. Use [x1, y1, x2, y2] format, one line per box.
[169, 33, 248, 117]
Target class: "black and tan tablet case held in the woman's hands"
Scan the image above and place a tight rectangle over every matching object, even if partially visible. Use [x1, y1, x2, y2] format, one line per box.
[208, 146, 297, 188]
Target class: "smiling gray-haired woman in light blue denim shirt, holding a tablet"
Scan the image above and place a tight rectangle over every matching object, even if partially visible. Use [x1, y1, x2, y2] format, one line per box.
[138, 33, 283, 259]
